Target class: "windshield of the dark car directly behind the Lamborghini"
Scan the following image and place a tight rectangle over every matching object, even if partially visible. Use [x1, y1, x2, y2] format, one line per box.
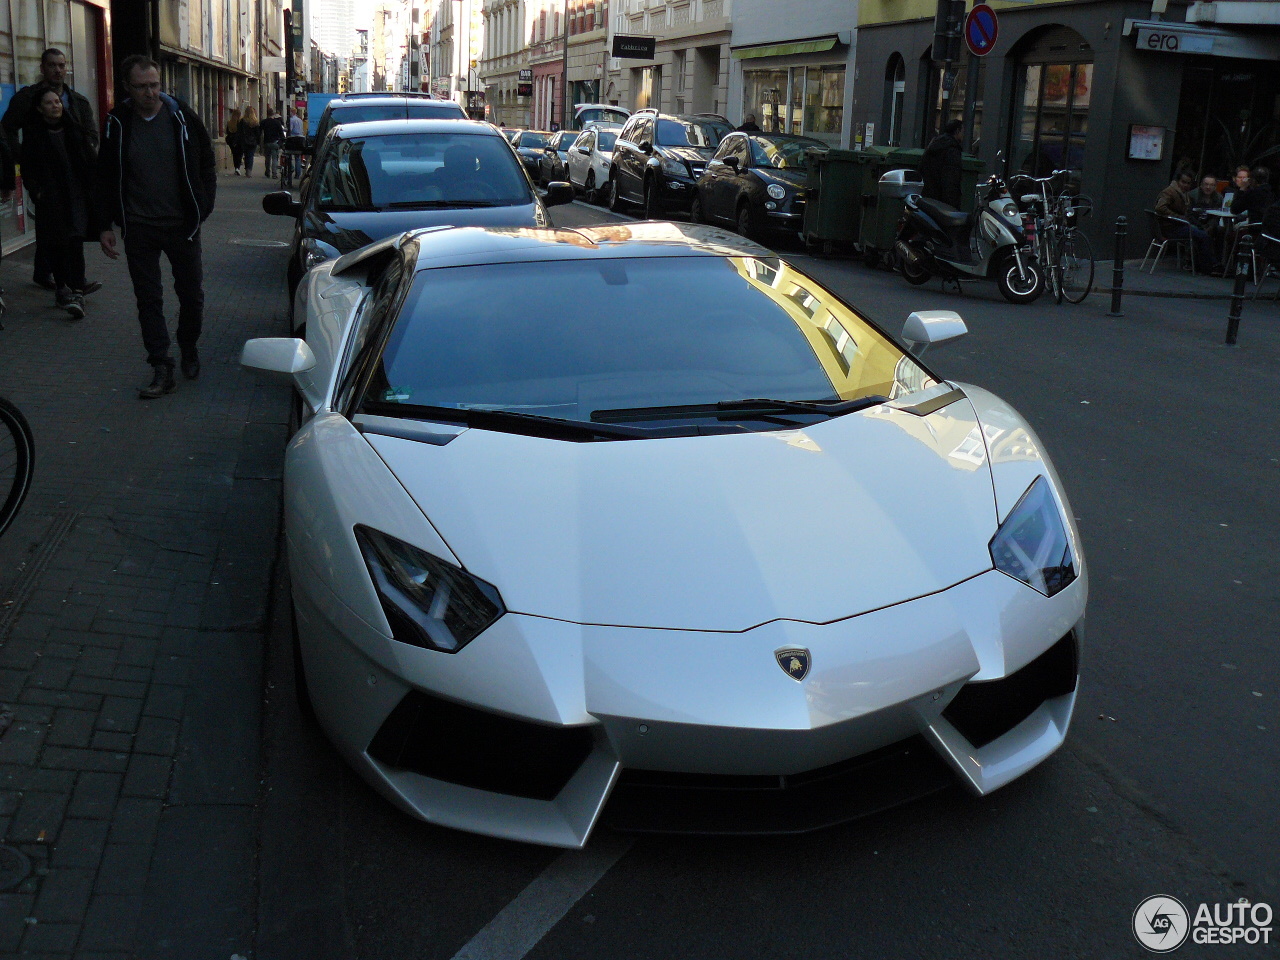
[316, 133, 534, 210]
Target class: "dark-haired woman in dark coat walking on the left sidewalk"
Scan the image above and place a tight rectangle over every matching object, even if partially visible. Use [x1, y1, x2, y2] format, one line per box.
[22, 90, 97, 320]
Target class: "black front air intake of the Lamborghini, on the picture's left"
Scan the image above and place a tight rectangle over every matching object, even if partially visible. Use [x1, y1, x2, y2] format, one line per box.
[369, 690, 593, 800]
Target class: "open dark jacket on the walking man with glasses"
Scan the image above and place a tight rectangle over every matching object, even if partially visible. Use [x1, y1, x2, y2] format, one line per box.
[96, 93, 218, 237]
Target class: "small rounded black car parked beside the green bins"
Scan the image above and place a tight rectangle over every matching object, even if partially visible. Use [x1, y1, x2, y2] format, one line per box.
[691, 133, 827, 238]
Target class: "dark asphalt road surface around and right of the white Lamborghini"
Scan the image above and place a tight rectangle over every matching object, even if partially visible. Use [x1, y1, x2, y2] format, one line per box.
[255, 197, 1280, 960]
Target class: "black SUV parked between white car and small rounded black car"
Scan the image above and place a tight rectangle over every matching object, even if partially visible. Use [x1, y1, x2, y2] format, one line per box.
[609, 110, 733, 220]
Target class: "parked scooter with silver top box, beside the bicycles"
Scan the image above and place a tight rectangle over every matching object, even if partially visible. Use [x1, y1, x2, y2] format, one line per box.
[893, 161, 1044, 303]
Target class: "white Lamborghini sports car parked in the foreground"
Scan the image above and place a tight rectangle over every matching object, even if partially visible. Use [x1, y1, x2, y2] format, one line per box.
[241, 223, 1088, 847]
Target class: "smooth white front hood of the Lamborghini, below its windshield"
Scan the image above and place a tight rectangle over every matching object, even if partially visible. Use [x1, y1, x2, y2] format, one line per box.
[366, 401, 996, 631]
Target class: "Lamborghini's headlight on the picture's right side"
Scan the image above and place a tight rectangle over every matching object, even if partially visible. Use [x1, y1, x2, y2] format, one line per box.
[991, 476, 1078, 596]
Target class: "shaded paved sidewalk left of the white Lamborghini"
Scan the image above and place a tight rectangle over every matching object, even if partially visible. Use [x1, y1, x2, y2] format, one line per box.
[0, 177, 288, 960]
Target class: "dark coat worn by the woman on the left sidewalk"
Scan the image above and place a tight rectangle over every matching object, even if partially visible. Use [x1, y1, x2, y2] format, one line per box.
[22, 114, 97, 243]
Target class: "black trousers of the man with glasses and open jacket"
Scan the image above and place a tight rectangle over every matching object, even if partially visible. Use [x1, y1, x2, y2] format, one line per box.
[124, 225, 205, 364]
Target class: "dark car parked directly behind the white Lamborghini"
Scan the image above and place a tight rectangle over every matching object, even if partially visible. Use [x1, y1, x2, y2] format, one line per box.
[262, 120, 573, 309]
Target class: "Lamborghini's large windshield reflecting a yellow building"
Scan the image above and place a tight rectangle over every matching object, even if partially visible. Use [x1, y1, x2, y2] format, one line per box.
[364, 256, 934, 429]
